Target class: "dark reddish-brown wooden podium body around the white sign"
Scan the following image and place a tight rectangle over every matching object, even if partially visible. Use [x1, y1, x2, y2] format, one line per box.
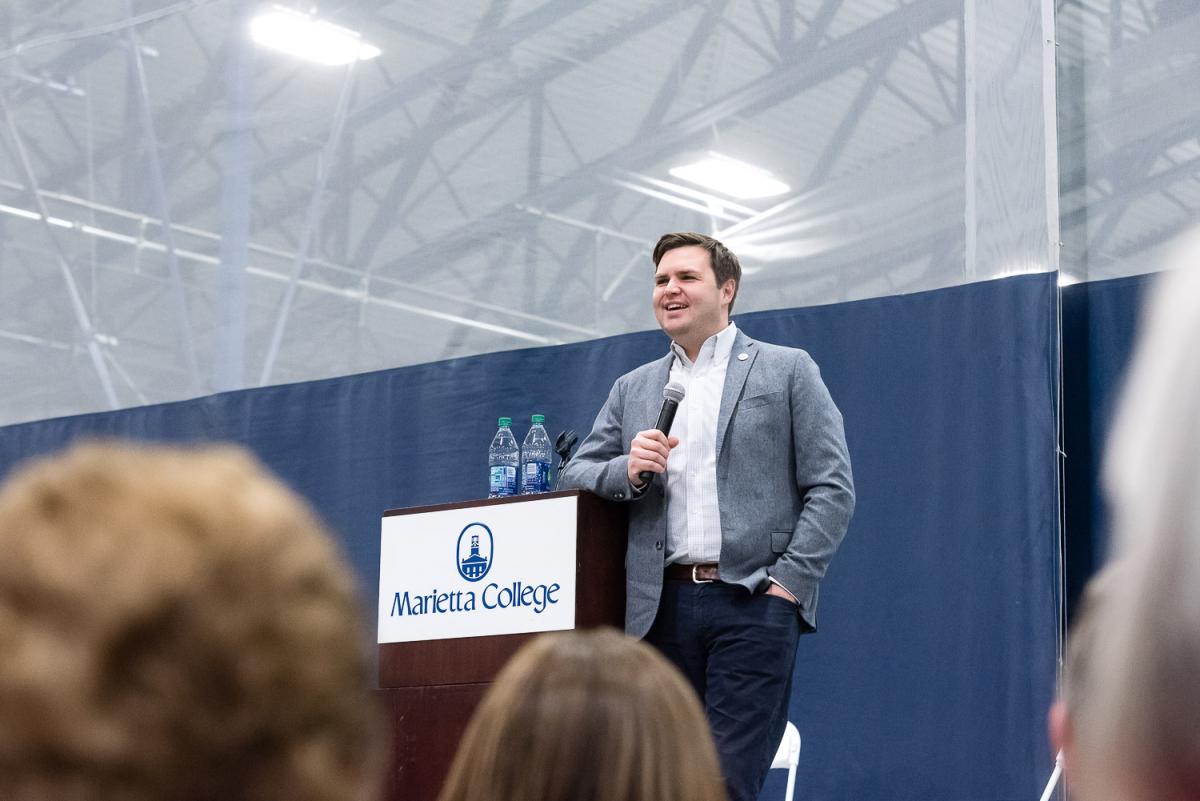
[378, 490, 626, 801]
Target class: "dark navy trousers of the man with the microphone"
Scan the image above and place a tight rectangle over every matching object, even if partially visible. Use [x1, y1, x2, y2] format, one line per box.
[646, 579, 800, 801]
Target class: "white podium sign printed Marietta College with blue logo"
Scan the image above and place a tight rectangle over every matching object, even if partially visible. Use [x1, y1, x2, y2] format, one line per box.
[378, 496, 578, 644]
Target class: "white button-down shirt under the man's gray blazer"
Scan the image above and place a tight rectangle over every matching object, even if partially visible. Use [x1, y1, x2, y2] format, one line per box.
[666, 323, 738, 565]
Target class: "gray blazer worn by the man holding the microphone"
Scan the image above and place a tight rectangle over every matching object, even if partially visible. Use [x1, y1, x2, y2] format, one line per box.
[559, 331, 854, 637]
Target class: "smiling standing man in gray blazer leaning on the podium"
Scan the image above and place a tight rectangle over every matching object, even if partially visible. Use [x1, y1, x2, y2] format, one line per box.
[560, 234, 854, 801]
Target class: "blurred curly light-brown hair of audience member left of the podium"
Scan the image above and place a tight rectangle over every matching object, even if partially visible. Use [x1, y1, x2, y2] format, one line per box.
[0, 444, 378, 801]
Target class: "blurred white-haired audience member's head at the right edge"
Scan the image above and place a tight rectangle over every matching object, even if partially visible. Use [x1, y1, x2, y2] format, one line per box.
[1076, 248, 1200, 801]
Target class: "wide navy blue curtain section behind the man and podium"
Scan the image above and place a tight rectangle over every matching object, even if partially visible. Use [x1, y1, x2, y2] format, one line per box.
[7, 275, 1060, 801]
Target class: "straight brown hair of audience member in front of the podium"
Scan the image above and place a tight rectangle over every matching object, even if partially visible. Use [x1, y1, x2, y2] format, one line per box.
[439, 630, 725, 801]
